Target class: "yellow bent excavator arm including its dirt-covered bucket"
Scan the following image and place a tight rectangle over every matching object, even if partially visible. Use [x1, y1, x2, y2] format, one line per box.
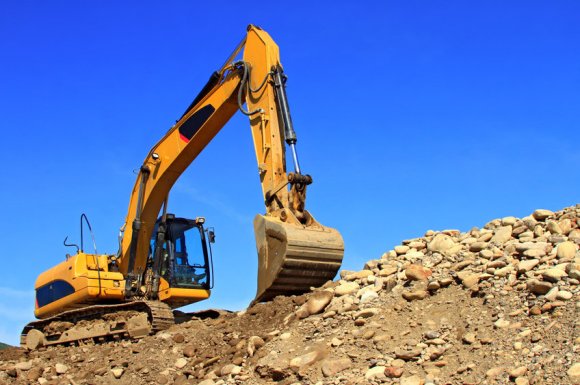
[118, 26, 344, 301]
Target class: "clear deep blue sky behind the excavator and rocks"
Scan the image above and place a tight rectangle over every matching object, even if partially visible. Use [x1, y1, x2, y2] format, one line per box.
[0, 1, 580, 344]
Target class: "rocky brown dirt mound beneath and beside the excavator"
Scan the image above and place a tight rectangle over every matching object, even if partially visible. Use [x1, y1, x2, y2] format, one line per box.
[0, 205, 580, 385]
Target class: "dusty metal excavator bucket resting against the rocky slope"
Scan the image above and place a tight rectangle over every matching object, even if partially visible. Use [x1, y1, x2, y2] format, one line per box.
[254, 215, 344, 303]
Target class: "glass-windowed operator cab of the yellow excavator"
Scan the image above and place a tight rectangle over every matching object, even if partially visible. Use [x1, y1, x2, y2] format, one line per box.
[149, 214, 214, 289]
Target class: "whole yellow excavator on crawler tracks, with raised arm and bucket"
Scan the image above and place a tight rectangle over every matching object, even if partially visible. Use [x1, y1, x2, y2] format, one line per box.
[21, 25, 344, 349]
